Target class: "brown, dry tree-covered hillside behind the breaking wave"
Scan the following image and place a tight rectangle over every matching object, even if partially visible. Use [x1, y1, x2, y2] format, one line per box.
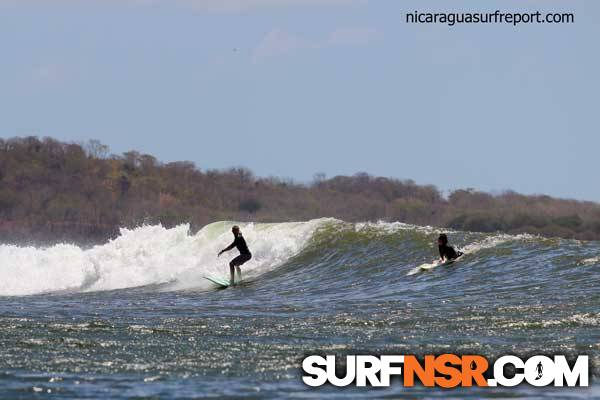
[0, 137, 600, 243]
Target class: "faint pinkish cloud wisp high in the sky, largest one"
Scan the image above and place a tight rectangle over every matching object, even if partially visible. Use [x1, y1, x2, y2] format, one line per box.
[252, 28, 382, 62]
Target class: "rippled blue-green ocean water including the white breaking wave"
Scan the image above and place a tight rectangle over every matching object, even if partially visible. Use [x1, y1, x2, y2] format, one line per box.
[0, 219, 600, 399]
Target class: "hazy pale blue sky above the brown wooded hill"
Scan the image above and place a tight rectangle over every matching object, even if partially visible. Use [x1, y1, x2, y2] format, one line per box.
[0, 0, 600, 201]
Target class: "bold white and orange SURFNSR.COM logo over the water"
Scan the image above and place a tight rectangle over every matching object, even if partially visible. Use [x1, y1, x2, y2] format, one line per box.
[302, 354, 589, 388]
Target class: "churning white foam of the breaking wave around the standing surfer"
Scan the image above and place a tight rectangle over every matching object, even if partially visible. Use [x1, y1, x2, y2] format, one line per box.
[0, 219, 330, 296]
